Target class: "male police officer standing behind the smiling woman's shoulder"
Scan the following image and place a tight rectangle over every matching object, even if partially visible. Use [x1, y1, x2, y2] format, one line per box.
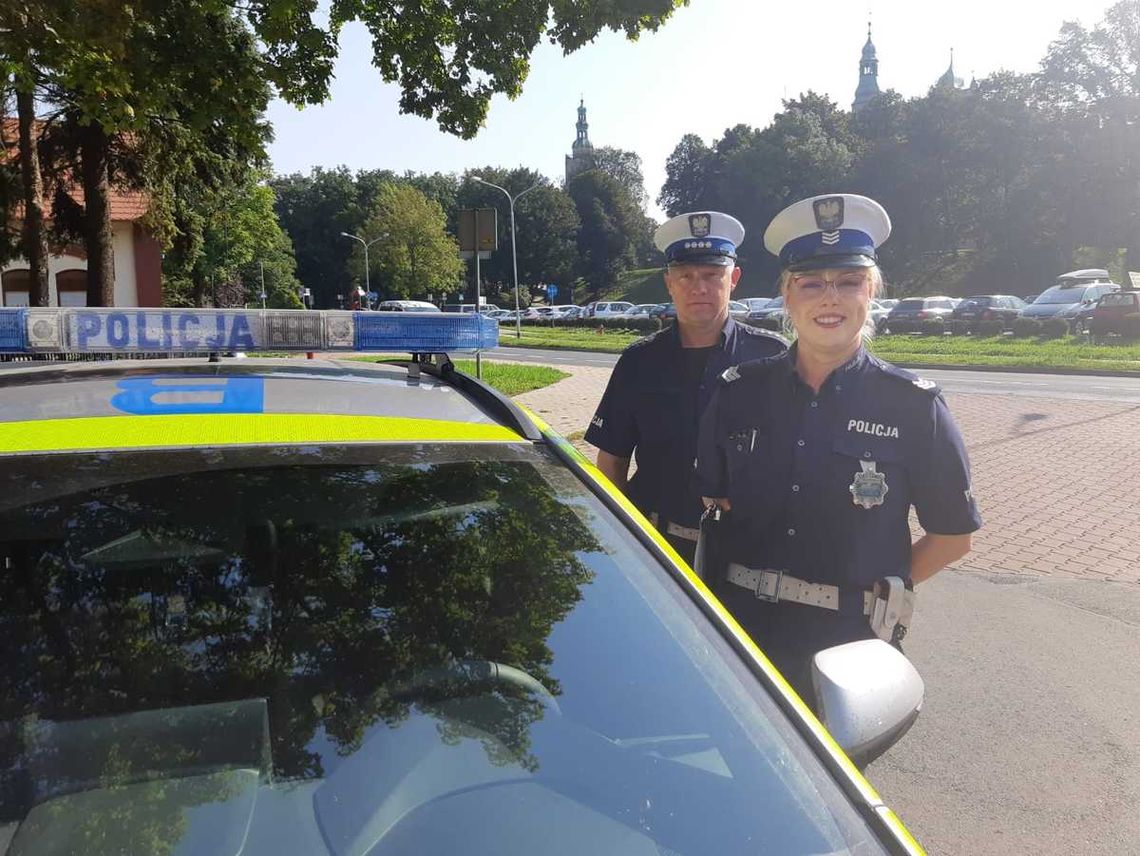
[586, 211, 787, 564]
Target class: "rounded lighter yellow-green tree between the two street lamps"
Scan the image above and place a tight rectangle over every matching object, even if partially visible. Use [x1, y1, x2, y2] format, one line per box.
[353, 182, 463, 297]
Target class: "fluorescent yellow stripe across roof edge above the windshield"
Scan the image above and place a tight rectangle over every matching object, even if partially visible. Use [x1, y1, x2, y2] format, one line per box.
[0, 414, 522, 454]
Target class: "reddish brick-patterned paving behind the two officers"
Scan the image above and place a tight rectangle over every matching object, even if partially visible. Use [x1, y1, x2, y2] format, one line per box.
[518, 366, 1140, 582]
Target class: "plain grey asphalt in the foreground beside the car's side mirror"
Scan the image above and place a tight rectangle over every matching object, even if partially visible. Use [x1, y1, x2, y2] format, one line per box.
[866, 571, 1140, 856]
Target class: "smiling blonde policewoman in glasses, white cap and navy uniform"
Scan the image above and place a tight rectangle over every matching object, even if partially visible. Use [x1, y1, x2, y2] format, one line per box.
[698, 194, 982, 703]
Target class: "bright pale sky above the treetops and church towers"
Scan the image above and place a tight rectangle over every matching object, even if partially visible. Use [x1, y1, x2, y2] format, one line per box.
[269, 0, 1107, 219]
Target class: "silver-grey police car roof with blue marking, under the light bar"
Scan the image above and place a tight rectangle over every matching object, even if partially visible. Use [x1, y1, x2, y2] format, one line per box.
[0, 358, 537, 451]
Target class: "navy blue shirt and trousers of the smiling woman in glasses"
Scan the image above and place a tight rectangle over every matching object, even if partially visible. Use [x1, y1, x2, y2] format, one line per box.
[697, 345, 982, 651]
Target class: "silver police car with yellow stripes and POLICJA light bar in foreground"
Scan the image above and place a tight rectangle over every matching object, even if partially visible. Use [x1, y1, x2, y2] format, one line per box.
[0, 309, 921, 856]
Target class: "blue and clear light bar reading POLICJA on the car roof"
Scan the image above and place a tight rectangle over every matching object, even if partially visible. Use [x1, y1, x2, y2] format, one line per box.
[0, 308, 498, 354]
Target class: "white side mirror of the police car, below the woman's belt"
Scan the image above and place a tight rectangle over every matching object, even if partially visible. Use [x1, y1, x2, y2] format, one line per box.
[812, 639, 926, 767]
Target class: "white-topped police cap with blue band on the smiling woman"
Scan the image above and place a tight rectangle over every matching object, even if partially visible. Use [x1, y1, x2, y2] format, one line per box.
[764, 194, 890, 270]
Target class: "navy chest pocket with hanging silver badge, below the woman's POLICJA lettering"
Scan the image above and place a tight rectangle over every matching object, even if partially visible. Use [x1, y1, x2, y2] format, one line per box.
[828, 433, 911, 522]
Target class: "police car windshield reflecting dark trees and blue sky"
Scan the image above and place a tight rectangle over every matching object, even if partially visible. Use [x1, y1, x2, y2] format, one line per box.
[0, 445, 881, 856]
